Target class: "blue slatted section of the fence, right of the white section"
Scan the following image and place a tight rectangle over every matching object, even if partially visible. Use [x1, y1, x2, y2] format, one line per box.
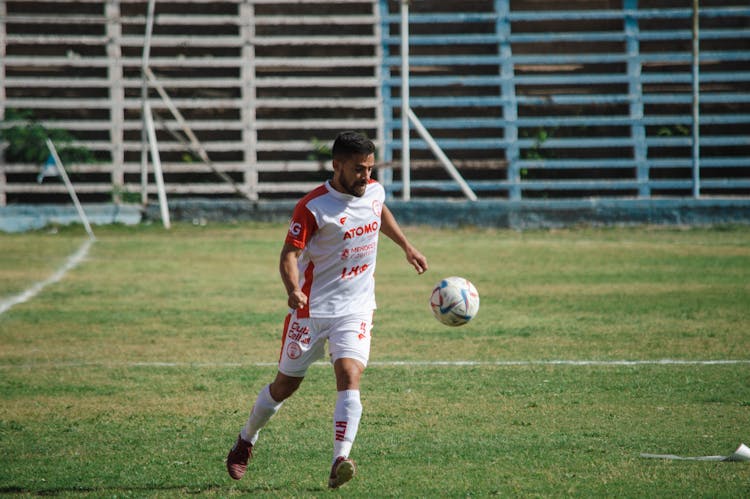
[380, 0, 750, 200]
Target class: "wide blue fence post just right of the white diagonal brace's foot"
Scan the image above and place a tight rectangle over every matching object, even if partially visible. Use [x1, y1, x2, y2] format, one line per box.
[495, 0, 521, 201]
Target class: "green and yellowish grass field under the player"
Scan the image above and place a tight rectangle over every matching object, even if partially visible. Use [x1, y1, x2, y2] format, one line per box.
[0, 224, 750, 497]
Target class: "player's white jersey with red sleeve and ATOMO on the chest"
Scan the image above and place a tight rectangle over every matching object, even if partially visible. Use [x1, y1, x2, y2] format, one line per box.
[286, 180, 385, 317]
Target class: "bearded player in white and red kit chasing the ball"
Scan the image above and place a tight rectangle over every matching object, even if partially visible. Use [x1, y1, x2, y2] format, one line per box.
[227, 132, 427, 488]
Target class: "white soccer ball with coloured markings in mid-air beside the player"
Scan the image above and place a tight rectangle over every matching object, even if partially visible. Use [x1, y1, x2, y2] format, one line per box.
[430, 277, 479, 326]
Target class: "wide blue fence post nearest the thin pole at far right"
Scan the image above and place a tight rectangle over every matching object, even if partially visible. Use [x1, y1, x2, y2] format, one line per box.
[623, 0, 651, 198]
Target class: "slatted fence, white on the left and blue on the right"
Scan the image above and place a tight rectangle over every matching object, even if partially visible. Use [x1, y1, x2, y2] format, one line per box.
[0, 0, 750, 204]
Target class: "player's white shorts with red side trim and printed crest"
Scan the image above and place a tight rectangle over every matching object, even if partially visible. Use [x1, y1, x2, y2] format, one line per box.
[279, 310, 373, 378]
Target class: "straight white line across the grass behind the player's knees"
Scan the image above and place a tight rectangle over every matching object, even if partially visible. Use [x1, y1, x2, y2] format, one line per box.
[0, 359, 750, 369]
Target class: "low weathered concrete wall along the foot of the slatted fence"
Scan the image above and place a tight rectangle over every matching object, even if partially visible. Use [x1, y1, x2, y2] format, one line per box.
[0, 198, 750, 232]
